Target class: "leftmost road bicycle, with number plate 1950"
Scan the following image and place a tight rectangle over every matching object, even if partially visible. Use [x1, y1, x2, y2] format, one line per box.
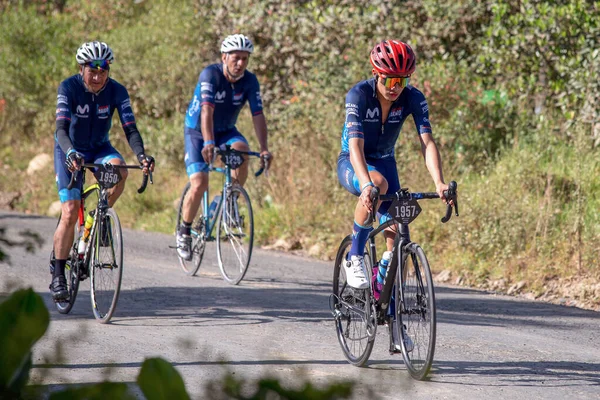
[50, 163, 153, 323]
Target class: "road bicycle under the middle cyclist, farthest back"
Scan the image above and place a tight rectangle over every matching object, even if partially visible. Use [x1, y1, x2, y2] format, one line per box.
[171, 145, 268, 285]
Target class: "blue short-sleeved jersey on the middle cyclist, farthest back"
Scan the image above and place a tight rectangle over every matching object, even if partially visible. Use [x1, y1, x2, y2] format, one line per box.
[185, 64, 263, 136]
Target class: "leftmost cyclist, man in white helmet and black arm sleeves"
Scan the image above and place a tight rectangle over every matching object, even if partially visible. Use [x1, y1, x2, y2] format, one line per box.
[50, 41, 154, 301]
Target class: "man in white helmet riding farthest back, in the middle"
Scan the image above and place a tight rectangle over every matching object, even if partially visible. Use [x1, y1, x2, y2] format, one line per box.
[177, 34, 272, 260]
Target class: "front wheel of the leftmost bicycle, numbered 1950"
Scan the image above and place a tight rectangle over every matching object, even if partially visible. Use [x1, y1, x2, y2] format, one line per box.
[90, 208, 123, 323]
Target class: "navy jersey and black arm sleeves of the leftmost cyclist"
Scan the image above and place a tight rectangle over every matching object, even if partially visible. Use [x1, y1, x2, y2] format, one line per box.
[56, 74, 138, 154]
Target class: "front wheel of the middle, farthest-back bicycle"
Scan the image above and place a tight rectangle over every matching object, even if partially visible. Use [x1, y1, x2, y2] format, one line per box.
[217, 185, 254, 285]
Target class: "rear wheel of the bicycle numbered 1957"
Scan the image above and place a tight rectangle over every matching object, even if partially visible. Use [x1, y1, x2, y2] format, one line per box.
[333, 236, 377, 367]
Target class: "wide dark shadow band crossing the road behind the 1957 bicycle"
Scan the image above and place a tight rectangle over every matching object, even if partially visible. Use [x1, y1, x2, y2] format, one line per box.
[40, 277, 600, 329]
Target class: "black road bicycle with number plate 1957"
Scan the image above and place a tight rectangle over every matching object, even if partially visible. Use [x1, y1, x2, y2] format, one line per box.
[330, 181, 458, 380]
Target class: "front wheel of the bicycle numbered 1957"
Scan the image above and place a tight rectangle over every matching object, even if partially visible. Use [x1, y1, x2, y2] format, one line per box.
[397, 243, 436, 380]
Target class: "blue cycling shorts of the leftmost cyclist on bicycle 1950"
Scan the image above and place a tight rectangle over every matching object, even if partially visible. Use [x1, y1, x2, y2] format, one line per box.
[54, 142, 125, 203]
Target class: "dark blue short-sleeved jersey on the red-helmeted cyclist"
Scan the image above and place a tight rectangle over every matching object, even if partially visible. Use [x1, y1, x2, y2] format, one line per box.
[342, 78, 431, 159]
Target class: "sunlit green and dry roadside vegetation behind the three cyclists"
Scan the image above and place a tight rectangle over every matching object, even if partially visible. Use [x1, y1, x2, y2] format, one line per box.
[0, 0, 600, 309]
